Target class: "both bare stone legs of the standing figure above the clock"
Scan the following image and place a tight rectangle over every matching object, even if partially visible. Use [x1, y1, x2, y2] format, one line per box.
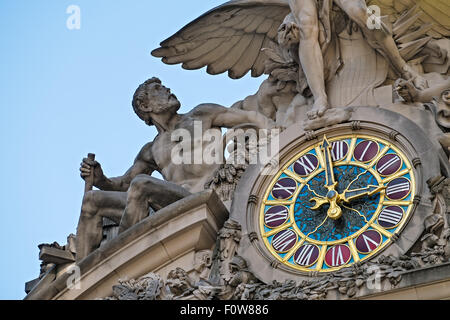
[289, 0, 426, 119]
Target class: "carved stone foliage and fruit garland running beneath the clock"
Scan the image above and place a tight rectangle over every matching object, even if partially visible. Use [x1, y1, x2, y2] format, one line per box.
[106, 208, 450, 300]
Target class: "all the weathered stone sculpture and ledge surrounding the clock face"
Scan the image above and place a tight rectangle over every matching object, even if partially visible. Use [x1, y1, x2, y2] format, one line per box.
[26, 0, 450, 300]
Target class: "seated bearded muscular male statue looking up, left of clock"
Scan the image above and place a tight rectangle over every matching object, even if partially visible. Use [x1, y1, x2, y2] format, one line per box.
[76, 78, 272, 261]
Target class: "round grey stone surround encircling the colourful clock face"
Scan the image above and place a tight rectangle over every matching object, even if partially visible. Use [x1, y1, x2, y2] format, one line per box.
[230, 106, 442, 283]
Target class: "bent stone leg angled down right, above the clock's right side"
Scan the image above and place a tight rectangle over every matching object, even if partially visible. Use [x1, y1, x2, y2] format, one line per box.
[335, 0, 427, 89]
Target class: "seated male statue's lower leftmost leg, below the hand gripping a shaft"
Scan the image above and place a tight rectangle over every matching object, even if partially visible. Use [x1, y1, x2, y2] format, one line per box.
[76, 191, 127, 261]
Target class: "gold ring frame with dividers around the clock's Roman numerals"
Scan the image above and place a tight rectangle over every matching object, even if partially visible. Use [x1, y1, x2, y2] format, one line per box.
[257, 134, 416, 273]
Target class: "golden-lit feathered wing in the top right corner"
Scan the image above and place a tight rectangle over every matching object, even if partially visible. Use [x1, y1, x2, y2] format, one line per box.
[367, 0, 450, 39]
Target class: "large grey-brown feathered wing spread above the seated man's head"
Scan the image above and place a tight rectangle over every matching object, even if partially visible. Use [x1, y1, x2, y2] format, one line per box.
[152, 0, 290, 79]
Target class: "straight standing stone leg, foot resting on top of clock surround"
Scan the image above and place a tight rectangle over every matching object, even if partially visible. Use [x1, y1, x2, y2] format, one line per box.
[289, 0, 329, 119]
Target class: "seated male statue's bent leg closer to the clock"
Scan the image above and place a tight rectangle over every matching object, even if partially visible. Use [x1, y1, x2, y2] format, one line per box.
[119, 174, 191, 233]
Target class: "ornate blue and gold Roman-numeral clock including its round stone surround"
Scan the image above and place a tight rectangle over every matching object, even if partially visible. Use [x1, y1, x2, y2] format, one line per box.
[230, 107, 442, 283]
